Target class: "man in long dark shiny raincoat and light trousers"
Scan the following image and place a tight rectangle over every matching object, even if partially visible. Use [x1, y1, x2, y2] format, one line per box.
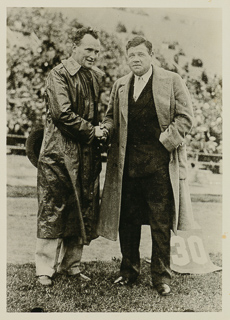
[35, 28, 103, 285]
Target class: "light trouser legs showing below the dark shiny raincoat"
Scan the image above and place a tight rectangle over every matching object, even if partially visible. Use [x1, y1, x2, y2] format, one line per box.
[35, 237, 83, 277]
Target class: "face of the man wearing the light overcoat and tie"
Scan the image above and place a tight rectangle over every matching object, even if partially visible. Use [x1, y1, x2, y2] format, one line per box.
[127, 43, 152, 76]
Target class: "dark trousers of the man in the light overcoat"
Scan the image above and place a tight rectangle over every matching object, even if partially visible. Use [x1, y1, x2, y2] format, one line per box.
[119, 165, 173, 285]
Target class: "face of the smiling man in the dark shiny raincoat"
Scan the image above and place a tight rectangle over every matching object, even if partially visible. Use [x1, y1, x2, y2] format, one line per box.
[72, 34, 100, 69]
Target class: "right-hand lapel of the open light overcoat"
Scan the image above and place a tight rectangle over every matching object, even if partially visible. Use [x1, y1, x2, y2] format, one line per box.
[153, 66, 171, 131]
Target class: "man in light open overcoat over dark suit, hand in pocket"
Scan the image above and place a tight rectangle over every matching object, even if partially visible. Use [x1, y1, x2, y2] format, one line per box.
[98, 37, 194, 295]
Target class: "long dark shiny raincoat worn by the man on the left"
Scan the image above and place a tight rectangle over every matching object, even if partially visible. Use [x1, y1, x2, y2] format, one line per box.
[37, 57, 103, 244]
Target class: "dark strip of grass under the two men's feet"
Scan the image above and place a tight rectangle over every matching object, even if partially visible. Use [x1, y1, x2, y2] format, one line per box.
[7, 254, 222, 312]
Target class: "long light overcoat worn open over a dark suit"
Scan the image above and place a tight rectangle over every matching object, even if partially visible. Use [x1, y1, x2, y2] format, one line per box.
[97, 66, 194, 240]
